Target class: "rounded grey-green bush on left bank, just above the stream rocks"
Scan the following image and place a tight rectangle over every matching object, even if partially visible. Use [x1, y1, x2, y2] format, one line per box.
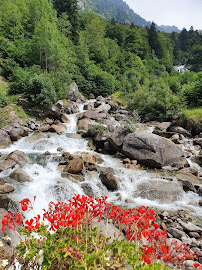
[25, 74, 57, 107]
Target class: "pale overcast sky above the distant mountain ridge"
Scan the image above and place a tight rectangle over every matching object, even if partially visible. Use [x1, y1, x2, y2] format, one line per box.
[123, 0, 202, 30]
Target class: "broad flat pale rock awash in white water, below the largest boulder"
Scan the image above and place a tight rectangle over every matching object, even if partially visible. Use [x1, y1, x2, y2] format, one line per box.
[134, 180, 183, 204]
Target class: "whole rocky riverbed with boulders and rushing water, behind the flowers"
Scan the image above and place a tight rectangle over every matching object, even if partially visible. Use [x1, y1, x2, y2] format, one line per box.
[0, 86, 202, 269]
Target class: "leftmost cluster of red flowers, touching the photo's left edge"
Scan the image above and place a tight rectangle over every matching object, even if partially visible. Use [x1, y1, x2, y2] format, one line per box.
[1, 211, 23, 232]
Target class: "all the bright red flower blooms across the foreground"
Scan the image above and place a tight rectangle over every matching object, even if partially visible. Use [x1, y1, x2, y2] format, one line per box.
[2, 195, 202, 270]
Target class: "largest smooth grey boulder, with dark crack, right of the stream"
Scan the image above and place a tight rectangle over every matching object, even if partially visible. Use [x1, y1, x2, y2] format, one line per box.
[121, 132, 183, 168]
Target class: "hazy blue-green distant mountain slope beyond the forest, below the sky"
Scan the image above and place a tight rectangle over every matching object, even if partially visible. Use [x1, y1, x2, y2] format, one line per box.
[79, 0, 180, 33]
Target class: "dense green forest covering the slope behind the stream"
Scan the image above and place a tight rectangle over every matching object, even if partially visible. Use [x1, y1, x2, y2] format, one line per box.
[0, 0, 202, 120]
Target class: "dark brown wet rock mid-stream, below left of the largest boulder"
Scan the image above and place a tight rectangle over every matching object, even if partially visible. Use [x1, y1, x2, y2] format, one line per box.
[100, 168, 119, 191]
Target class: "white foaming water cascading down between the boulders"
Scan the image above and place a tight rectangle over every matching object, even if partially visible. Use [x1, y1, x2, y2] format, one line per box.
[0, 102, 202, 216]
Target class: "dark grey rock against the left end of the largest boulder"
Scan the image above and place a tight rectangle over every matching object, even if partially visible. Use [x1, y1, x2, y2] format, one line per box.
[108, 129, 127, 152]
